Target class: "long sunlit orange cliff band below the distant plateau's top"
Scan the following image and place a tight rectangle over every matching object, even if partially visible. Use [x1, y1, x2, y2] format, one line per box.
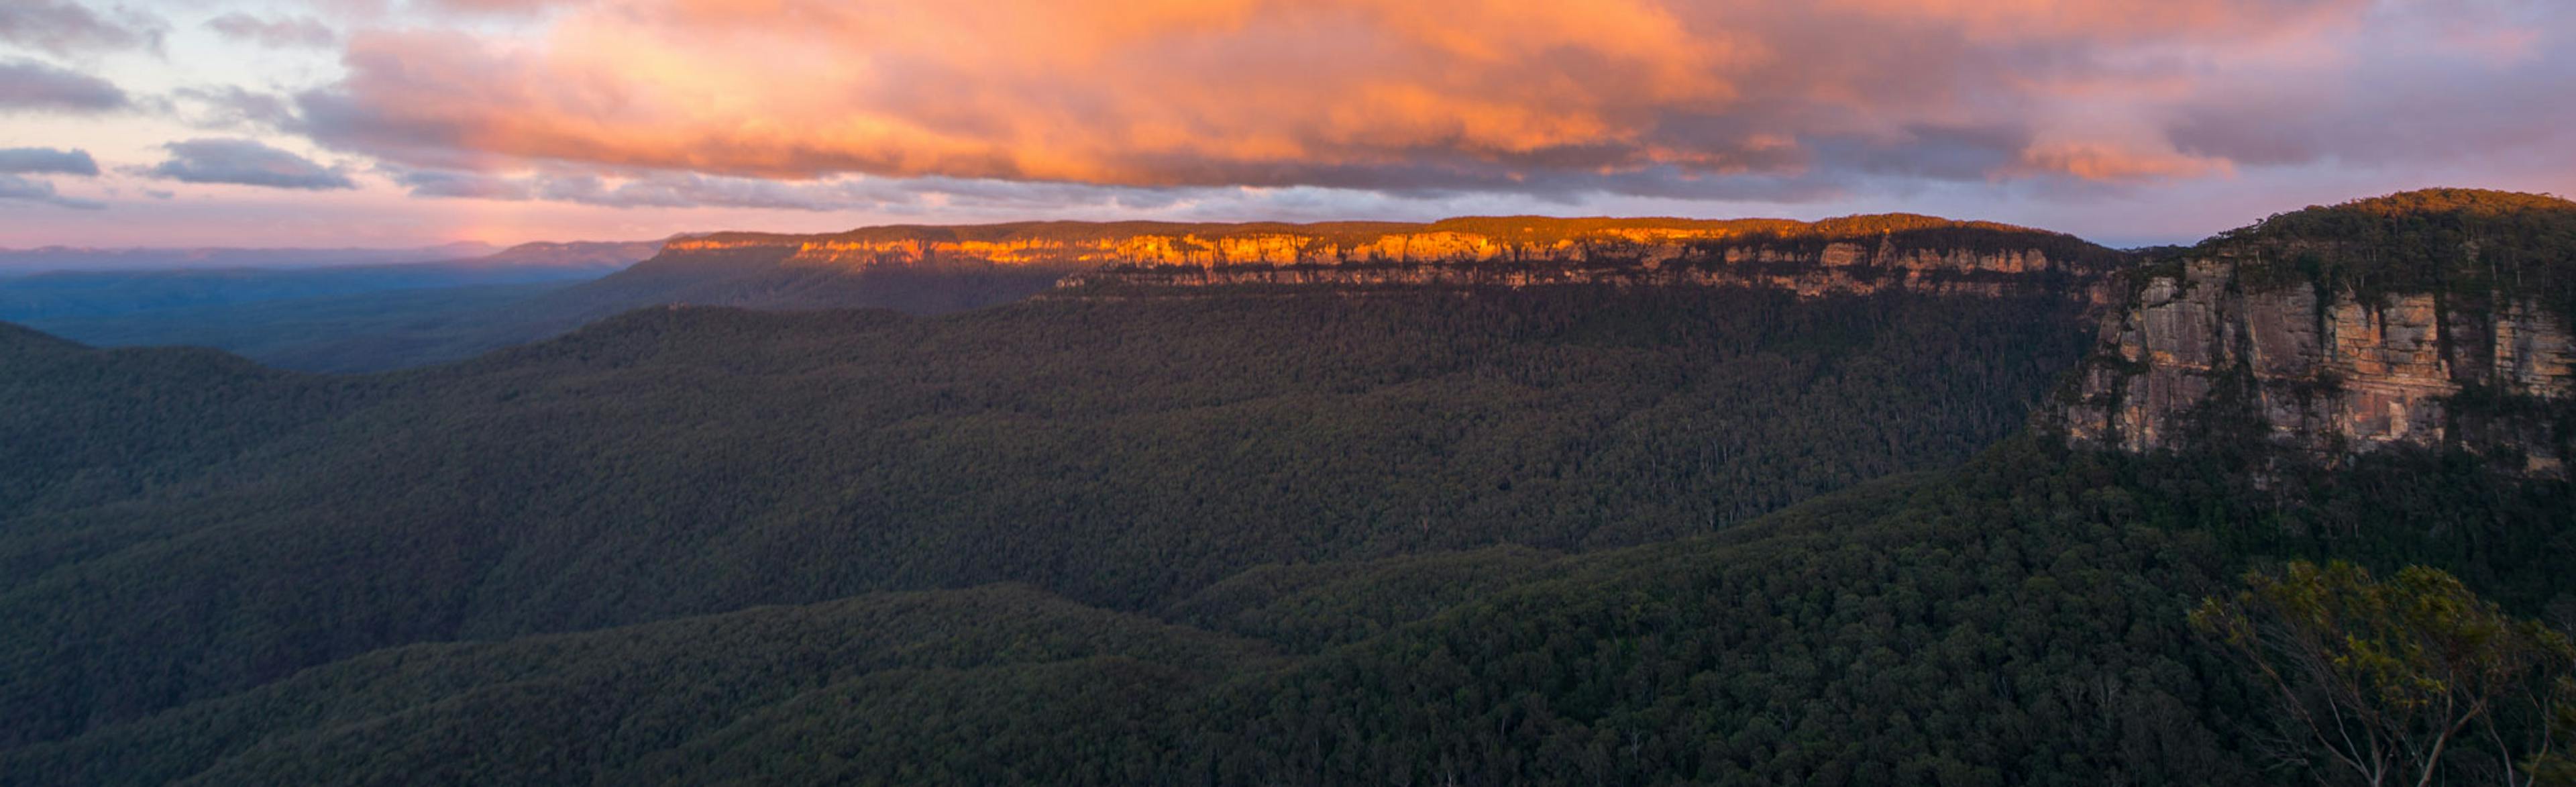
[665, 217, 2117, 297]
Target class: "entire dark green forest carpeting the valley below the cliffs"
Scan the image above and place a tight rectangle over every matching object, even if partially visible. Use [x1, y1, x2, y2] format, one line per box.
[0, 193, 2576, 784]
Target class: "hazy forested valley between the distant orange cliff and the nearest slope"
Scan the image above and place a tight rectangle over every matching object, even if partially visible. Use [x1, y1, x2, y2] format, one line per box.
[0, 289, 2079, 743]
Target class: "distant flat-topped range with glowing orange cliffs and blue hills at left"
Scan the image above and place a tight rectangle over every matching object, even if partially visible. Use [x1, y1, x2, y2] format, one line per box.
[91, 214, 2123, 372]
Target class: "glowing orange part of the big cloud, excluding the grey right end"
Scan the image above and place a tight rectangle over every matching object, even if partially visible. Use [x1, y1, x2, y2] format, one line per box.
[301, 0, 2365, 193]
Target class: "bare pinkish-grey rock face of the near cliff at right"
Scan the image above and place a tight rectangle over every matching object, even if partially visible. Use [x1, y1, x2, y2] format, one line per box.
[2051, 258, 2576, 475]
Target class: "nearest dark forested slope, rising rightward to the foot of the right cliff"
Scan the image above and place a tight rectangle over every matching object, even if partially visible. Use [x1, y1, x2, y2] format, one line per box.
[0, 431, 2576, 784]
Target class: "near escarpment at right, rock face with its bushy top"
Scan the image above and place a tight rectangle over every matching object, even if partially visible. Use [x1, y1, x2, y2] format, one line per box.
[2048, 193, 2576, 477]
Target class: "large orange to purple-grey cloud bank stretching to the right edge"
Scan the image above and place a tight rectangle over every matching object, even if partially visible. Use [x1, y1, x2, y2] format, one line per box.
[261, 0, 2576, 207]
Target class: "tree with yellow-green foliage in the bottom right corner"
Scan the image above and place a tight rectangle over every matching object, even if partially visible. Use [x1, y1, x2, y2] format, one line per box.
[2192, 562, 2576, 784]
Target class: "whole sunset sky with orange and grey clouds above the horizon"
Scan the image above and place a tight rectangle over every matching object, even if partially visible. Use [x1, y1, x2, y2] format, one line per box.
[0, 0, 2576, 248]
